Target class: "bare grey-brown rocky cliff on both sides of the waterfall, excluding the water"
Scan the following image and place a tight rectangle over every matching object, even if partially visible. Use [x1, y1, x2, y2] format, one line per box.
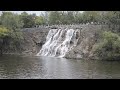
[12, 25, 107, 58]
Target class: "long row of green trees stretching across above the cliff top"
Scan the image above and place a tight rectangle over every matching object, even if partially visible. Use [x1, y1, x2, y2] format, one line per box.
[0, 11, 120, 28]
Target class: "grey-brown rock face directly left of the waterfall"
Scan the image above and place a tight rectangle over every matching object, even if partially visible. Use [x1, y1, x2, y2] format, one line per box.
[21, 28, 49, 55]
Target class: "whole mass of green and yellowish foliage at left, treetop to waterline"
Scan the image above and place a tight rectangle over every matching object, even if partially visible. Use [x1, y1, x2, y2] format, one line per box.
[0, 12, 23, 54]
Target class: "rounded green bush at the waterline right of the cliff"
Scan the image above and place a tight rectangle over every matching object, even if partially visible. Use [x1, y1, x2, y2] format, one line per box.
[94, 31, 120, 60]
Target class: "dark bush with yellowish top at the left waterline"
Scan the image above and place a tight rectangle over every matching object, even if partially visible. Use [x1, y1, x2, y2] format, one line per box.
[0, 26, 23, 55]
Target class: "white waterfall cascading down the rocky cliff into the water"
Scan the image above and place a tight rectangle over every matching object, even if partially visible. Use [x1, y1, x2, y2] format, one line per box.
[37, 28, 80, 57]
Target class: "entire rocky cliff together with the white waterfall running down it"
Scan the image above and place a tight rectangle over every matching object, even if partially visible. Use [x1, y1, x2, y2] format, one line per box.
[4, 25, 108, 59]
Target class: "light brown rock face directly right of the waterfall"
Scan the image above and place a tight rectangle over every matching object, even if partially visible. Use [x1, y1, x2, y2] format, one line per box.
[65, 26, 102, 59]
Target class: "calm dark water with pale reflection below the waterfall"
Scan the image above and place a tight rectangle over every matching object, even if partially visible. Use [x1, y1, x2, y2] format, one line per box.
[0, 56, 120, 79]
